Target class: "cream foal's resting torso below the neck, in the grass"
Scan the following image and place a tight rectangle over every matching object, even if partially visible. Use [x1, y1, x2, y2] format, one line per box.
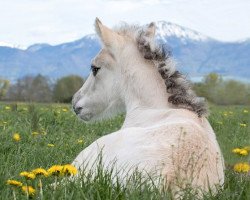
[72, 109, 224, 190]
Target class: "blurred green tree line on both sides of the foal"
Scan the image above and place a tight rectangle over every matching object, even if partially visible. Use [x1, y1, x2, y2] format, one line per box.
[0, 73, 250, 105]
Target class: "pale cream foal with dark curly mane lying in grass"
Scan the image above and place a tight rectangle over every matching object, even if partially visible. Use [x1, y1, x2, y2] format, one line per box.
[72, 20, 224, 197]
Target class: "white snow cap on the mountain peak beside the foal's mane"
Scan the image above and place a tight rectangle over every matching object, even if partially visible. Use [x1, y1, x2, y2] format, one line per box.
[156, 21, 209, 41]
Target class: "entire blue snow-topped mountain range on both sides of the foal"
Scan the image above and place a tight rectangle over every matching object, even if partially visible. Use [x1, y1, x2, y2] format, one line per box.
[0, 21, 250, 80]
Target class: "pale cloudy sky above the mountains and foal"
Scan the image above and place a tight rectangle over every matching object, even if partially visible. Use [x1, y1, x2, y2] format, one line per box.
[0, 0, 250, 47]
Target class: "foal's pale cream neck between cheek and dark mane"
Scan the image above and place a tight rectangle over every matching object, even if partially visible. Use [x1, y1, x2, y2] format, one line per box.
[123, 63, 171, 128]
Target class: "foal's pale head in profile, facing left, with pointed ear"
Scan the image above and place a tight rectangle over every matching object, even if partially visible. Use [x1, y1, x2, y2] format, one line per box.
[72, 19, 145, 121]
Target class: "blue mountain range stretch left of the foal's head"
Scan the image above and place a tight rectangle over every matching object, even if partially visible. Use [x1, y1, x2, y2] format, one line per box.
[0, 35, 100, 80]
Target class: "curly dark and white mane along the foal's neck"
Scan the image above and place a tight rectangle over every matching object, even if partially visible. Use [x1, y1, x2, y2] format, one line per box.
[115, 24, 208, 117]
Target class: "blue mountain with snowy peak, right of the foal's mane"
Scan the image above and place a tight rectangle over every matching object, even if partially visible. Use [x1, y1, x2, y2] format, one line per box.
[157, 22, 250, 79]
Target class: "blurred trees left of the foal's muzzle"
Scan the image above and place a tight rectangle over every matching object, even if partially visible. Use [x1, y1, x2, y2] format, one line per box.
[0, 74, 84, 103]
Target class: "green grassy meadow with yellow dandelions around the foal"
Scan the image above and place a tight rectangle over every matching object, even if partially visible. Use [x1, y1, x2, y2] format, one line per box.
[0, 103, 250, 200]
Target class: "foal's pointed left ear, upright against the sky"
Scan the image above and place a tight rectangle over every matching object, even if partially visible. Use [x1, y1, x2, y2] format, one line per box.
[95, 18, 122, 50]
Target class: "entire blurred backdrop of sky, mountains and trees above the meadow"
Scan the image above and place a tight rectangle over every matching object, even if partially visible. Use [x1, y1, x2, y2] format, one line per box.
[0, 0, 250, 105]
